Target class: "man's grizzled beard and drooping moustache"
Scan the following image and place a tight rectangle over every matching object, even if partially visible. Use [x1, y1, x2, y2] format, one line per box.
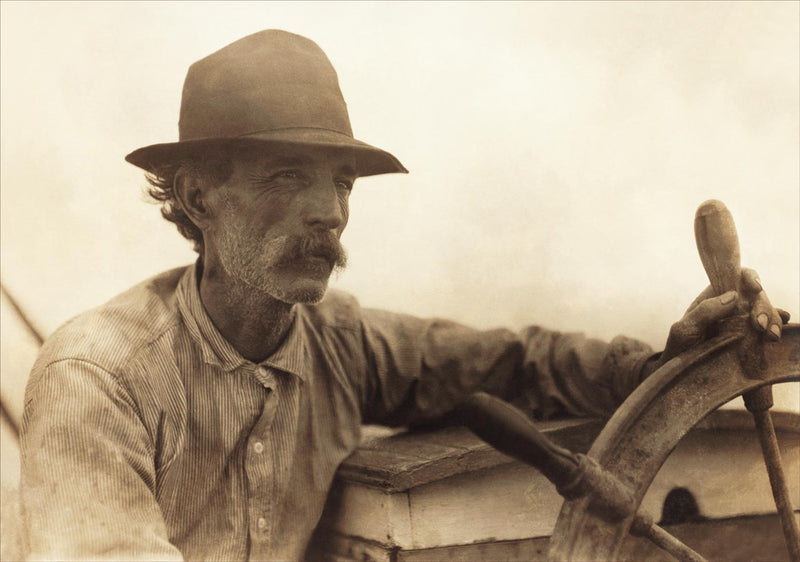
[218, 221, 347, 304]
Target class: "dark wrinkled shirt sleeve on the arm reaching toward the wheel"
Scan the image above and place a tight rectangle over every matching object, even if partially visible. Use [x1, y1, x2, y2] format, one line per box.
[362, 309, 653, 425]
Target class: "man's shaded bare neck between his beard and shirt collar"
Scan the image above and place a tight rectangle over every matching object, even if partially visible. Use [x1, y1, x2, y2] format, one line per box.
[200, 256, 294, 363]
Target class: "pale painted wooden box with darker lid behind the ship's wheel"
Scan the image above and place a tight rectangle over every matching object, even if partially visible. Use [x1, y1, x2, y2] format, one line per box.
[315, 410, 800, 560]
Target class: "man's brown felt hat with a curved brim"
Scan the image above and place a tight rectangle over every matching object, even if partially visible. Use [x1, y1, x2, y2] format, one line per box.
[130, 30, 408, 176]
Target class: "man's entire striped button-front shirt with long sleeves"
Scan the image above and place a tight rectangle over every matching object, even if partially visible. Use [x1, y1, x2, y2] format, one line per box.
[22, 266, 651, 560]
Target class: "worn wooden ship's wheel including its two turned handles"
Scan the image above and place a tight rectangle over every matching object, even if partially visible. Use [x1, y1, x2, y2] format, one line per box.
[462, 201, 800, 562]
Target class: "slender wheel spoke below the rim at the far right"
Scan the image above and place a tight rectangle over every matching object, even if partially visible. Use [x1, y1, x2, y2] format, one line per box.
[744, 386, 800, 562]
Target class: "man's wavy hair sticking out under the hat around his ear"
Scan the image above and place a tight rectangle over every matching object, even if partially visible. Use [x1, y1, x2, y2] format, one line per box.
[145, 151, 233, 253]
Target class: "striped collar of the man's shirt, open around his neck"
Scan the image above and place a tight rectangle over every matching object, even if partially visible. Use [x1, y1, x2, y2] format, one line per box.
[176, 262, 310, 381]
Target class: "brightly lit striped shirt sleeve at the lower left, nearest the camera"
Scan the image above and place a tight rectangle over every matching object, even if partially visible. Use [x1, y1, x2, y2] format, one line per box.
[21, 360, 182, 560]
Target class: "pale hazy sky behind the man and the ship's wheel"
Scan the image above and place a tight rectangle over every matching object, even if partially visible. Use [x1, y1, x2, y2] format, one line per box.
[0, 2, 800, 456]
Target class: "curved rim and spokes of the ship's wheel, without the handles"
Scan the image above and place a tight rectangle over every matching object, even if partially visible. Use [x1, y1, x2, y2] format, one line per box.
[550, 324, 800, 562]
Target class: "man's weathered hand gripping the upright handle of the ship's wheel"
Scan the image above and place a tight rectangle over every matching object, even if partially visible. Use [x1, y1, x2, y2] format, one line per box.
[652, 268, 789, 370]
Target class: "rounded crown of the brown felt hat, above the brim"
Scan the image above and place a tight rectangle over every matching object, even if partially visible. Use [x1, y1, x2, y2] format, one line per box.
[178, 30, 353, 141]
